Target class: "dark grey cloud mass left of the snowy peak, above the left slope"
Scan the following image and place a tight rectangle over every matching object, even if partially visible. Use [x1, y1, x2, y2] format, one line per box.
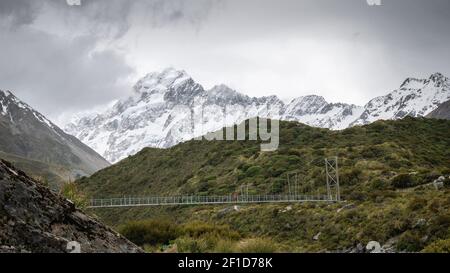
[0, 27, 133, 121]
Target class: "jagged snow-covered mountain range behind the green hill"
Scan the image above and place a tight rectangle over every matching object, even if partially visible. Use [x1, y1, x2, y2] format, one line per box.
[65, 68, 450, 162]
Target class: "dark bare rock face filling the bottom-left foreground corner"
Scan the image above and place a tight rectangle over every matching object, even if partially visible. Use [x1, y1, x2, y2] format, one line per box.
[0, 160, 142, 253]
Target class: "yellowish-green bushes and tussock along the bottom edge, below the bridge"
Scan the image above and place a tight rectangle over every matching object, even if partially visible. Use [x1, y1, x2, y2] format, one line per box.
[119, 219, 284, 253]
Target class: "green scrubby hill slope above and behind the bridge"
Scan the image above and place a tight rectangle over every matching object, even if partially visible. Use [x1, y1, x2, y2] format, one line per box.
[79, 118, 450, 198]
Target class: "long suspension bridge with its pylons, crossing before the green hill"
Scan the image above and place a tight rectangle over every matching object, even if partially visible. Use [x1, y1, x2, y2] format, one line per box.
[88, 157, 341, 208]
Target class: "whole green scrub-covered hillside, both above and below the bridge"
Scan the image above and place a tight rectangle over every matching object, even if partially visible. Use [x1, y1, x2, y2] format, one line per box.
[77, 118, 450, 252]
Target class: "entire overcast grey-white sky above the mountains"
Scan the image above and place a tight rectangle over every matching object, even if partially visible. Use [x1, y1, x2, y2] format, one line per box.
[0, 0, 450, 123]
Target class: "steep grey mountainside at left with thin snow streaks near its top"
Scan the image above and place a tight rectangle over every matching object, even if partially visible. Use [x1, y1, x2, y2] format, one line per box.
[0, 90, 109, 186]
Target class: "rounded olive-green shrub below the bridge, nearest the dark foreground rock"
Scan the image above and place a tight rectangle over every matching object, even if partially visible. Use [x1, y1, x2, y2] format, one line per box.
[119, 219, 179, 246]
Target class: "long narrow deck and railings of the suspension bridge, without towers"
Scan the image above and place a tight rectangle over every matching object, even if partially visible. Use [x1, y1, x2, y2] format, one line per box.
[88, 195, 337, 208]
